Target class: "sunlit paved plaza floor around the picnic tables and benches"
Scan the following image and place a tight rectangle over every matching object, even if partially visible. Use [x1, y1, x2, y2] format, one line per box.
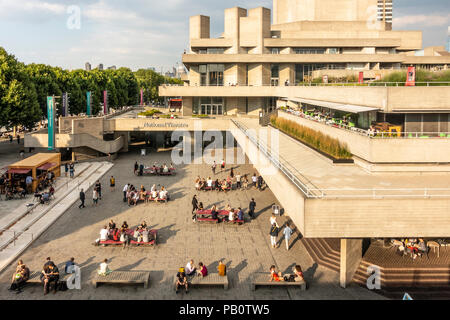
[0, 151, 383, 300]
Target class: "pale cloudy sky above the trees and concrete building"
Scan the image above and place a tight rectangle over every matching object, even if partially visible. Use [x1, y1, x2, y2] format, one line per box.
[0, 0, 450, 71]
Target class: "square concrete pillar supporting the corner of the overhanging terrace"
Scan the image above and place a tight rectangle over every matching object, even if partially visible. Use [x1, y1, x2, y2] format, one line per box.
[340, 239, 363, 288]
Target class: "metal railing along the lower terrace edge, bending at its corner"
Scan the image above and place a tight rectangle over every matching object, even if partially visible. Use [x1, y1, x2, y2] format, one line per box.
[231, 119, 450, 200]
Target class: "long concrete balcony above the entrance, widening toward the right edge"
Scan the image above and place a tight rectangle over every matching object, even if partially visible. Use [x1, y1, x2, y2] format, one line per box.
[159, 85, 450, 113]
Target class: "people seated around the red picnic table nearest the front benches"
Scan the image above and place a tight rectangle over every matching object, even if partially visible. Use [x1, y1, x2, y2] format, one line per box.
[96, 220, 155, 245]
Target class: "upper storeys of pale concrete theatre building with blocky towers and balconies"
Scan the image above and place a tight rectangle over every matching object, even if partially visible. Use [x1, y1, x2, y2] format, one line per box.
[159, 0, 450, 121]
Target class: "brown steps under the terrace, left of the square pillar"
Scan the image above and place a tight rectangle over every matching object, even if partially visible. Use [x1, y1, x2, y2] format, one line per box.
[302, 238, 341, 272]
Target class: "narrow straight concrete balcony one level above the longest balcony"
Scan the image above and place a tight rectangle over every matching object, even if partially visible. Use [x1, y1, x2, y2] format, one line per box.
[183, 54, 406, 65]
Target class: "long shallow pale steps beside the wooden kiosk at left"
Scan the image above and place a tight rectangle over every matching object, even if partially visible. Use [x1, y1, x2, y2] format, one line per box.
[0, 162, 113, 272]
